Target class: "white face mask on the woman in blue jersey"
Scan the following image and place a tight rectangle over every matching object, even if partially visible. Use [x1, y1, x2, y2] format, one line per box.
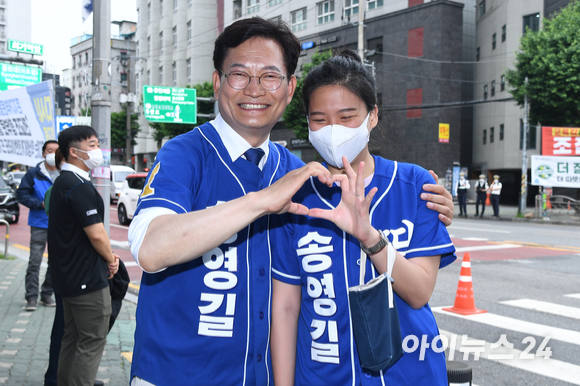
[308, 113, 371, 169]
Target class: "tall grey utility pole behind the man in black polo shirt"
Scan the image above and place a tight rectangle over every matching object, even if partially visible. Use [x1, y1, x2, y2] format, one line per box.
[91, 0, 111, 234]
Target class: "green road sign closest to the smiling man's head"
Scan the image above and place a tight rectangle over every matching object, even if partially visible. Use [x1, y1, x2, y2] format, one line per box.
[143, 86, 197, 123]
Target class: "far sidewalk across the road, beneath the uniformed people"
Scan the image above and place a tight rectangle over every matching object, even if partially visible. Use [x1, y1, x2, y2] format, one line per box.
[453, 201, 580, 226]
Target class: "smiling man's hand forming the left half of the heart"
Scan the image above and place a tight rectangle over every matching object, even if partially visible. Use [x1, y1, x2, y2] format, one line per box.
[255, 162, 332, 216]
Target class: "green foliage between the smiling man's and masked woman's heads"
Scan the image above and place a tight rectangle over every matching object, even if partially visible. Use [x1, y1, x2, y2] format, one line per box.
[283, 50, 332, 139]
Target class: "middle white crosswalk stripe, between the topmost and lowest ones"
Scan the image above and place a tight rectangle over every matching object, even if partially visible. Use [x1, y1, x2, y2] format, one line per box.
[432, 307, 580, 346]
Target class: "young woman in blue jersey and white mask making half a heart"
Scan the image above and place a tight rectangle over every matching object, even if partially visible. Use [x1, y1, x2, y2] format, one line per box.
[270, 51, 456, 386]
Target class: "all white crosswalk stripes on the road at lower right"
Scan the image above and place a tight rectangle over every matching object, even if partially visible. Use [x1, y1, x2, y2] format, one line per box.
[432, 294, 580, 385]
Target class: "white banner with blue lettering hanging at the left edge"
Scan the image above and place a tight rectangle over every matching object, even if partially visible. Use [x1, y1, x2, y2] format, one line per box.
[0, 81, 56, 166]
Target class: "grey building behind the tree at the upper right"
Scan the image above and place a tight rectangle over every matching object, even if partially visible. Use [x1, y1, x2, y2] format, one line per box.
[471, 0, 569, 205]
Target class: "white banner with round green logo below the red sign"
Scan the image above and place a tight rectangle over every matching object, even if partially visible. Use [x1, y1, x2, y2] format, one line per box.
[531, 155, 580, 188]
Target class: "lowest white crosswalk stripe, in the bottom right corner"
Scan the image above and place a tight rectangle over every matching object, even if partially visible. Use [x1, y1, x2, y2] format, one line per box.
[440, 328, 580, 385]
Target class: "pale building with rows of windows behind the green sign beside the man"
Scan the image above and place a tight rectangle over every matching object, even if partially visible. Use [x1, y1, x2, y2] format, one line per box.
[135, 0, 223, 170]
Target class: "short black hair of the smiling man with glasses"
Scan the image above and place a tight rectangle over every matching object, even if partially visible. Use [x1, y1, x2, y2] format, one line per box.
[213, 16, 301, 75]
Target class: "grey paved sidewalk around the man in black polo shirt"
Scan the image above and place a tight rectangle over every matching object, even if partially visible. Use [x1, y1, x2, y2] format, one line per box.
[0, 243, 136, 386]
